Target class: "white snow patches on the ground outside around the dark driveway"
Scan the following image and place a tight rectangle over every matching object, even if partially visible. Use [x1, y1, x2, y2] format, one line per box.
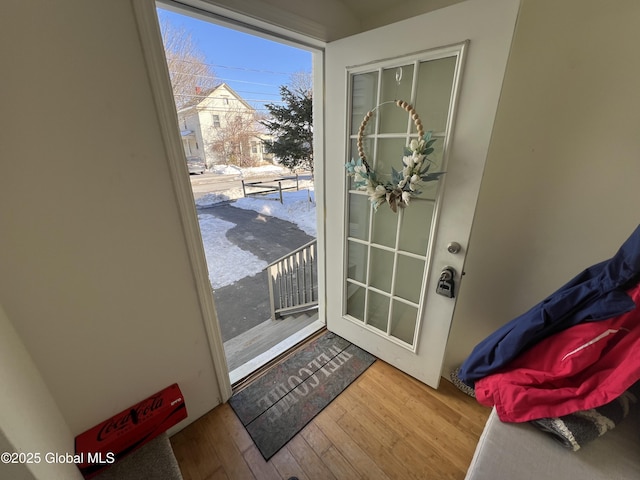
[196, 167, 317, 288]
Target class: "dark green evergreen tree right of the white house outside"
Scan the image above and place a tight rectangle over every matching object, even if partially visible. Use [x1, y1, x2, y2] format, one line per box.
[260, 85, 313, 174]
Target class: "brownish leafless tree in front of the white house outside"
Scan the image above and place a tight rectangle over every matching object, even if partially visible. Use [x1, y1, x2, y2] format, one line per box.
[210, 110, 261, 167]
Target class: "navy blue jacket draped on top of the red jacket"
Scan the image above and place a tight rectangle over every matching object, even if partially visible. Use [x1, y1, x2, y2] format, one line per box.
[458, 226, 640, 386]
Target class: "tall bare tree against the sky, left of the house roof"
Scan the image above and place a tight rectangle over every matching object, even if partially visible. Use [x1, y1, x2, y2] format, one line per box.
[158, 12, 218, 110]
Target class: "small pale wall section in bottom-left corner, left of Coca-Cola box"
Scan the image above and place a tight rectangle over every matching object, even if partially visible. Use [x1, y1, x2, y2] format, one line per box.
[0, 305, 82, 480]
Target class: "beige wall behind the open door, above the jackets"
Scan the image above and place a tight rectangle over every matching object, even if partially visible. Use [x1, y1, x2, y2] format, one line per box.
[443, 0, 640, 375]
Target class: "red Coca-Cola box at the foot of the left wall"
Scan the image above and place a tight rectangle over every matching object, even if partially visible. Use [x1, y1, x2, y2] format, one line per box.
[75, 383, 187, 479]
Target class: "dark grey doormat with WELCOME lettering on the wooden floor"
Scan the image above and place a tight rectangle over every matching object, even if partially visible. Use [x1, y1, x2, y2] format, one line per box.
[229, 332, 376, 460]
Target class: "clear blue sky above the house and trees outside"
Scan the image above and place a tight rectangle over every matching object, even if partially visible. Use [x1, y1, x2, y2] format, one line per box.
[158, 8, 312, 113]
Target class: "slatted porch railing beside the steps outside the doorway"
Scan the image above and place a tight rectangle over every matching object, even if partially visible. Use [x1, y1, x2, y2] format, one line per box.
[267, 240, 318, 320]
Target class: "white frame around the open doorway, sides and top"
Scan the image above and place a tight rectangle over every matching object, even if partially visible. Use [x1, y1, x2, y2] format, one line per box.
[132, 0, 326, 402]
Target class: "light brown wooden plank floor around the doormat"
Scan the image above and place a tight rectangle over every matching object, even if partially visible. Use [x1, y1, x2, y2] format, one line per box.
[171, 360, 490, 480]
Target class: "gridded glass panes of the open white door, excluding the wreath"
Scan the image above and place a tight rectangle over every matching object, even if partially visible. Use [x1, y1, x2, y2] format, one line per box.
[343, 51, 459, 351]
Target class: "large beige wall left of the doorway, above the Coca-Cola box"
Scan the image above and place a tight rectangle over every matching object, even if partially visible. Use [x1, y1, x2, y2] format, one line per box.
[0, 0, 221, 442]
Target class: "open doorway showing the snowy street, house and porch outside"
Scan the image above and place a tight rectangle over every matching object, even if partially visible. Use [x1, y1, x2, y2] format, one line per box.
[157, 4, 324, 384]
